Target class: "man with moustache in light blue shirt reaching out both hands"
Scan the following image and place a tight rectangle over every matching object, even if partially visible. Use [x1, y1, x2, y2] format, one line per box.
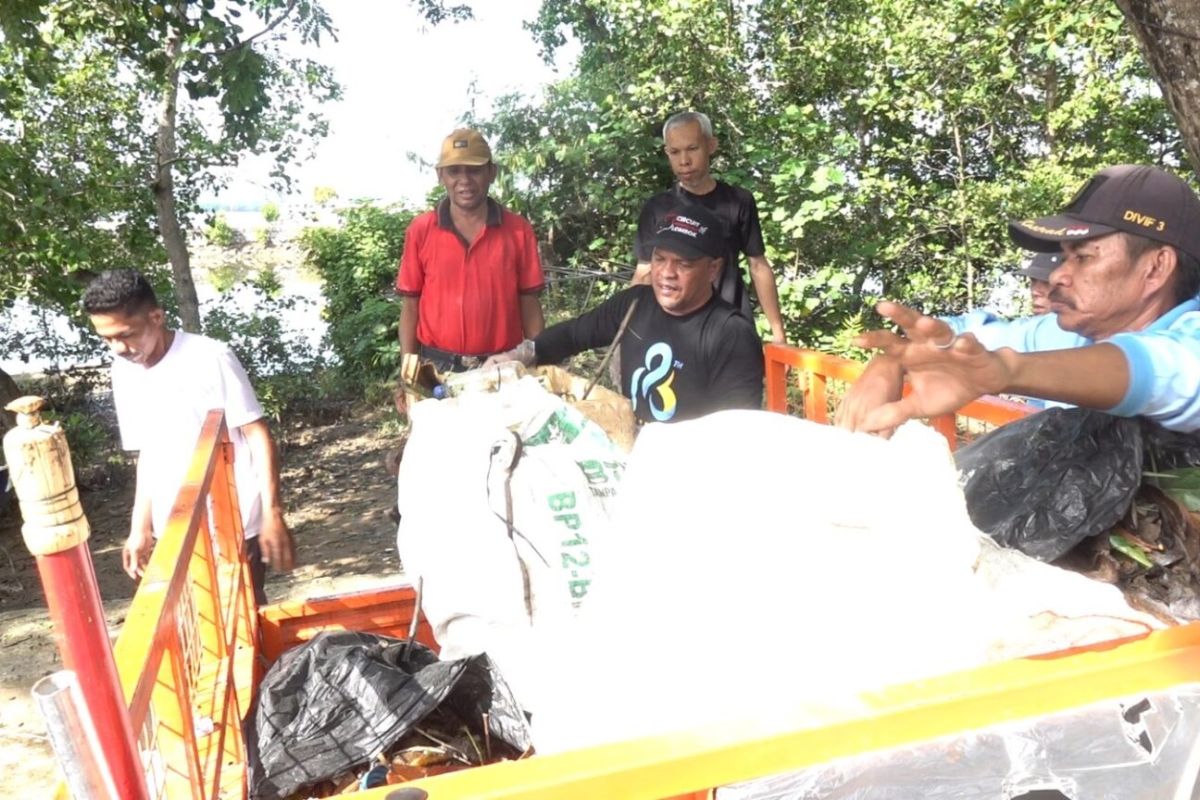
[838, 166, 1200, 433]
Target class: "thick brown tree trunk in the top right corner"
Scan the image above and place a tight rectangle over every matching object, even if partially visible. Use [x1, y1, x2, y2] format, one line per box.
[1116, 0, 1200, 175]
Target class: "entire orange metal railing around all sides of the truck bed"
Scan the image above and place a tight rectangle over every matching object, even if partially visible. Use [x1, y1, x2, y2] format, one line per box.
[44, 352, 1200, 800]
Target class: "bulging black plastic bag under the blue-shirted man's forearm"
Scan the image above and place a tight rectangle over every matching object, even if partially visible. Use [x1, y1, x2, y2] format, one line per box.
[954, 408, 1142, 561]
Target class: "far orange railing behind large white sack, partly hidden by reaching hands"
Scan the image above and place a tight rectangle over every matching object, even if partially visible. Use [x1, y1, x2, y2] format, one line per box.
[763, 344, 1036, 450]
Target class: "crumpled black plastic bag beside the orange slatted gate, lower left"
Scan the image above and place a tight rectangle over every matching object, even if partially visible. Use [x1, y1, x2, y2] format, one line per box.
[247, 631, 530, 800]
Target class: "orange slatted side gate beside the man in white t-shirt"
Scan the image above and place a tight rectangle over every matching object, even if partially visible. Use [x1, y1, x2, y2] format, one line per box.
[104, 411, 260, 798]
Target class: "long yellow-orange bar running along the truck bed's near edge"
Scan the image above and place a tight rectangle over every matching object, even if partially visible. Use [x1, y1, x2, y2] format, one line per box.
[355, 622, 1200, 800]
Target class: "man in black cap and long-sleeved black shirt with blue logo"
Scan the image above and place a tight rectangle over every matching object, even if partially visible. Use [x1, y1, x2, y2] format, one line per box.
[487, 205, 763, 422]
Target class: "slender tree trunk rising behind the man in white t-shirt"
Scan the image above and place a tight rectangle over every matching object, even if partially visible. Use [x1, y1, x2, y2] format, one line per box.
[154, 8, 200, 333]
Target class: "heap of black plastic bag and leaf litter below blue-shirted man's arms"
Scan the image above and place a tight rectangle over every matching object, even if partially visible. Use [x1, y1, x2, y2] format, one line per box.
[955, 409, 1200, 624]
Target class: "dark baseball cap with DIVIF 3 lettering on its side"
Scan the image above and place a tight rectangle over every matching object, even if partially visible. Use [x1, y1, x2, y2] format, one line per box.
[1008, 164, 1200, 258]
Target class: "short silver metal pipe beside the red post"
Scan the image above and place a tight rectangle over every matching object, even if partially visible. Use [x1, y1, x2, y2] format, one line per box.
[32, 669, 120, 800]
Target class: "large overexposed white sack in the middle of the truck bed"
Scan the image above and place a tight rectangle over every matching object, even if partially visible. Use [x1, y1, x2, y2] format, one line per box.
[528, 410, 1162, 758]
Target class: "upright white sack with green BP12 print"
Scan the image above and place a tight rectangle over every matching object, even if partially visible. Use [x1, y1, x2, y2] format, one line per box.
[396, 373, 629, 715]
